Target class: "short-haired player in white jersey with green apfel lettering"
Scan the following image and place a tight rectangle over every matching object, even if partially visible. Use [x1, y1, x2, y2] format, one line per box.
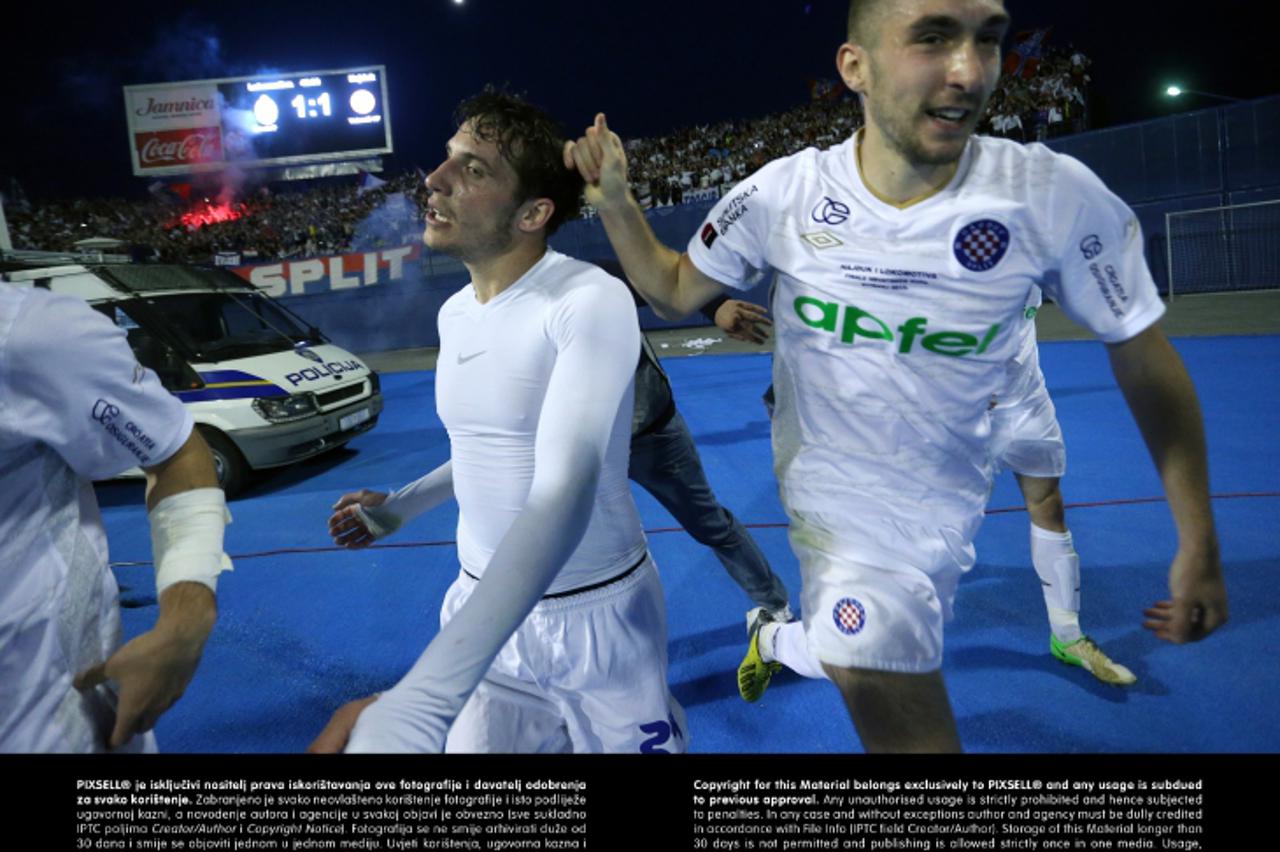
[564, 0, 1226, 751]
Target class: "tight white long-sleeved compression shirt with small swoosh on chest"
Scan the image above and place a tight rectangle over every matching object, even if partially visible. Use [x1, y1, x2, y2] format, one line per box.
[347, 251, 645, 752]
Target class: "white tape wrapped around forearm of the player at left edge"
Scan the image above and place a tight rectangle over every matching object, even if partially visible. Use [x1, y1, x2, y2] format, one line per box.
[150, 489, 232, 597]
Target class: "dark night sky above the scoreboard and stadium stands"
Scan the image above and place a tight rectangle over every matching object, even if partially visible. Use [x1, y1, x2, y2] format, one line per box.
[0, 0, 1280, 201]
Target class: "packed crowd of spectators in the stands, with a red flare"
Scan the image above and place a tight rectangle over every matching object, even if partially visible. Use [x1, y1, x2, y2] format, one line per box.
[5, 49, 1089, 264]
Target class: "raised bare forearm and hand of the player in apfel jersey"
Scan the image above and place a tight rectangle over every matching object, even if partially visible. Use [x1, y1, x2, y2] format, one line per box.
[564, 113, 724, 320]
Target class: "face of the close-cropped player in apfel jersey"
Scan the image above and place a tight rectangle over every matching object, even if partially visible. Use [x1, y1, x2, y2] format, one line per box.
[863, 0, 1009, 165]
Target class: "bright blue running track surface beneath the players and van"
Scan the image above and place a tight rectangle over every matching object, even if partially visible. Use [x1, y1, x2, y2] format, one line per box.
[99, 336, 1280, 752]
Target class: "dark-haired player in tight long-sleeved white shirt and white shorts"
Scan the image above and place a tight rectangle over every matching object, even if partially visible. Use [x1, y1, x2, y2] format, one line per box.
[311, 90, 687, 753]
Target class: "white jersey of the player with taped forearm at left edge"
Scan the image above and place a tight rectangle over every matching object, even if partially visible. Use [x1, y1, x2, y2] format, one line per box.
[0, 283, 192, 751]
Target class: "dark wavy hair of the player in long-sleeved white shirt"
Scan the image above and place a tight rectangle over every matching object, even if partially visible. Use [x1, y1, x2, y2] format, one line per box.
[453, 86, 584, 237]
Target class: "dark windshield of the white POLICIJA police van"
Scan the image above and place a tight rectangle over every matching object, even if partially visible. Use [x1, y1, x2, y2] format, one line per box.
[133, 293, 321, 361]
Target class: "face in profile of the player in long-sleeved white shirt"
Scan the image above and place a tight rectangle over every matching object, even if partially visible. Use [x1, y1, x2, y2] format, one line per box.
[422, 123, 520, 262]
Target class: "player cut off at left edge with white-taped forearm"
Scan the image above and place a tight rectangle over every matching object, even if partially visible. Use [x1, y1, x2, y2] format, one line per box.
[0, 283, 230, 752]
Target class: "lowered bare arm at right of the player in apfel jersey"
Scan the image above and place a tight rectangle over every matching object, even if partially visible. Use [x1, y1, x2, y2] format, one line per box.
[1108, 326, 1228, 643]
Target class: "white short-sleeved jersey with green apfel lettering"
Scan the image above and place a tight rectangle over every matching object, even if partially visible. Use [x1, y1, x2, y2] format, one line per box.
[689, 137, 1164, 525]
